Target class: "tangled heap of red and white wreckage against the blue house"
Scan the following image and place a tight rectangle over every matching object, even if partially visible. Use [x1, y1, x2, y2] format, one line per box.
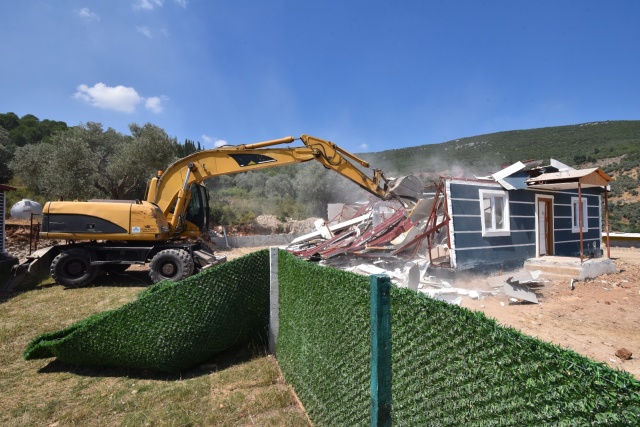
[287, 187, 449, 289]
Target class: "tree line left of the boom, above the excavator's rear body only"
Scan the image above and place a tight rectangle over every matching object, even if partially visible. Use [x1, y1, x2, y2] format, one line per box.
[0, 113, 202, 200]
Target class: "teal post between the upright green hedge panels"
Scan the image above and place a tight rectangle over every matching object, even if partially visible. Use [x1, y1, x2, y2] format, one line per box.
[370, 274, 391, 427]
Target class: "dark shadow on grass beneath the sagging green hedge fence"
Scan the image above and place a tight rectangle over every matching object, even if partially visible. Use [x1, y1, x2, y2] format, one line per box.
[38, 342, 267, 381]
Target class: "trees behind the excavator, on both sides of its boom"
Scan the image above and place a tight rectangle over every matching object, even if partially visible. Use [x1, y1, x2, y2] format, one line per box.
[0, 113, 366, 224]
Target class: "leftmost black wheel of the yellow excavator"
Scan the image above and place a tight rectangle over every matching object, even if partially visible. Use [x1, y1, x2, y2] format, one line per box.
[49, 249, 99, 288]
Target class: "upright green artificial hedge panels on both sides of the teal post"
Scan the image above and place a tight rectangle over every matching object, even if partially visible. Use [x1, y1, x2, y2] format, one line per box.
[277, 251, 640, 426]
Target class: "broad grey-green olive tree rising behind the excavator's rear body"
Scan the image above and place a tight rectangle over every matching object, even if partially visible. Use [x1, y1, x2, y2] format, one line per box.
[10, 122, 176, 200]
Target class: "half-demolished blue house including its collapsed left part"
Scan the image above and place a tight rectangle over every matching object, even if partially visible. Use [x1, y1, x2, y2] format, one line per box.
[287, 159, 611, 281]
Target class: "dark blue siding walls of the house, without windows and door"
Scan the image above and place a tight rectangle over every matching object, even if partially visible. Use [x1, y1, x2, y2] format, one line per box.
[449, 182, 600, 271]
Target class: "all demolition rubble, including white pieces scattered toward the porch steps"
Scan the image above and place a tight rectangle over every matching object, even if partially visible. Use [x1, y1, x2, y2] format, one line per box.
[286, 194, 540, 305]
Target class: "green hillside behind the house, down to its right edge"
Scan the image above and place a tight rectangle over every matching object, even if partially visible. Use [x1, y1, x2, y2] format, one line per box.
[362, 120, 640, 232]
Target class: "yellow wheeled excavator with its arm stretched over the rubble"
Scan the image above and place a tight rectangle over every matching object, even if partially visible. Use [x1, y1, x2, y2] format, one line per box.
[29, 135, 422, 287]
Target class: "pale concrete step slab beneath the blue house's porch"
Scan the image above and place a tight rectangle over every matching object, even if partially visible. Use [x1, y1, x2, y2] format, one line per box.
[524, 256, 619, 280]
